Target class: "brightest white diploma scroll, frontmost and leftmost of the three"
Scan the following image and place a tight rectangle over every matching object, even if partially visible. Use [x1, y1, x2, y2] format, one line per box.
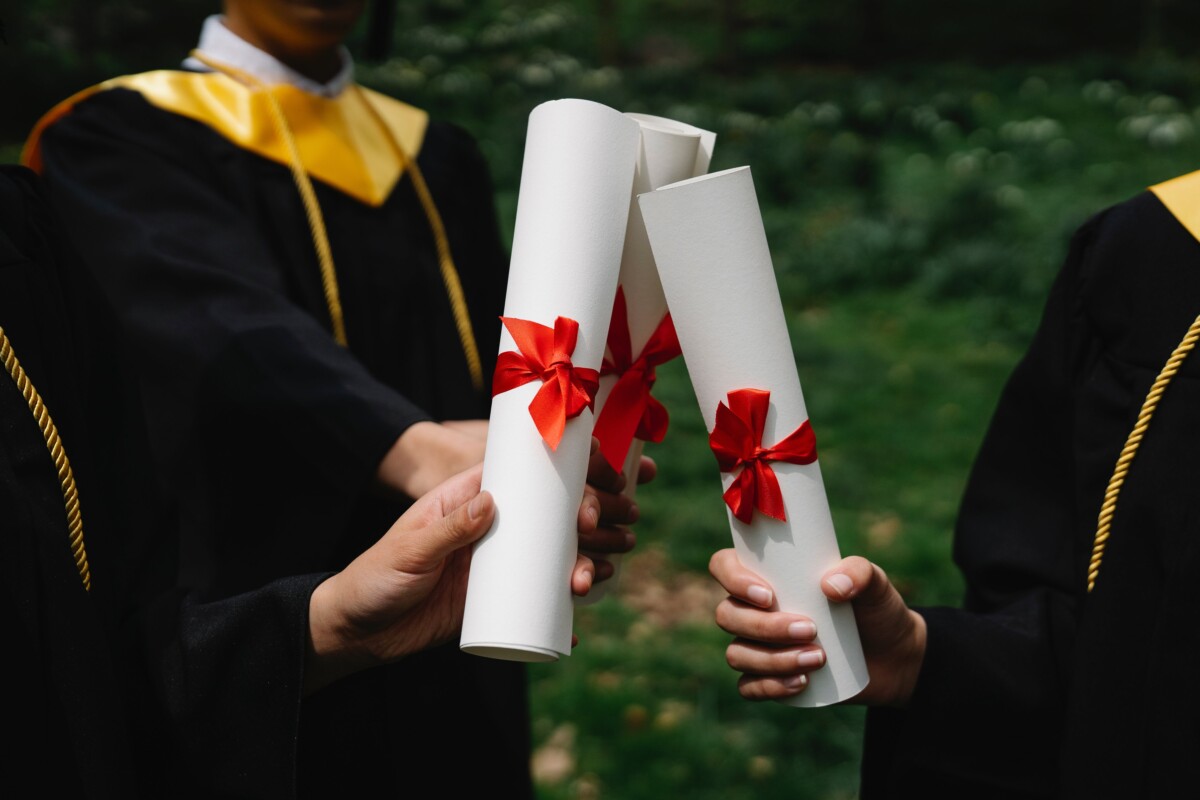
[460, 100, 638, 661]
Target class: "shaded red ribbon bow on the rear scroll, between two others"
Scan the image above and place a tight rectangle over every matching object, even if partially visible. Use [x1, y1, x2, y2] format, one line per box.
[593, 287, 679, 473]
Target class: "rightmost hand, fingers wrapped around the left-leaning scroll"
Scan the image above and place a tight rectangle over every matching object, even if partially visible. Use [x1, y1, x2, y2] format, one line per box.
[708, 549, 925, 708]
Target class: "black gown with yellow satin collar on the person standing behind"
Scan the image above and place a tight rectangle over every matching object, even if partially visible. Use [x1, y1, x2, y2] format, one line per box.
[26, 71, 532, 796]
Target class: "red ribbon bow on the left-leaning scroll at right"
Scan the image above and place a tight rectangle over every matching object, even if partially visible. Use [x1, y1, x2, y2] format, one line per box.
[708, 389, 817, 523]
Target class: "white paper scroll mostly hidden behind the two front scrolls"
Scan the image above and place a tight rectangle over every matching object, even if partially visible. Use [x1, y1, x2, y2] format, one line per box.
[575, 114, 716, 606]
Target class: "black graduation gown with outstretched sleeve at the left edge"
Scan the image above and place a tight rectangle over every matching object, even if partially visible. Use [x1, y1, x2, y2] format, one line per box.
[0, 167, 324, 800]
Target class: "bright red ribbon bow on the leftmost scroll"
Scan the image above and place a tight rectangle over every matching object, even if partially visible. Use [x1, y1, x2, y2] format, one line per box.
[492, 317, 600, 450]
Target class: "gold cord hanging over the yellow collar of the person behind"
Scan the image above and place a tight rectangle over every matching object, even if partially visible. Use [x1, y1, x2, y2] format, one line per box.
[192, 50, 484, 390]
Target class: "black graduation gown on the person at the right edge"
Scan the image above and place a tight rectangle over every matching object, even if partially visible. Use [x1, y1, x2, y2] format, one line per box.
[862, 192, 1200, 800]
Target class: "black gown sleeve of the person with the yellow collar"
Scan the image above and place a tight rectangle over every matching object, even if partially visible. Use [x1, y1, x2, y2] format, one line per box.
[32, 90, 430, 506]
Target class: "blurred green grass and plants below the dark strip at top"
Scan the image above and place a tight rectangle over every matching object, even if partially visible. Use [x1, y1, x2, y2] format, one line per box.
[420, 48, 1200, 800]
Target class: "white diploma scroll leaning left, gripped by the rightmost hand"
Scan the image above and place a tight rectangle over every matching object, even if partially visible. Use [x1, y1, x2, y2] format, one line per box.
[638, 167, 868, 706]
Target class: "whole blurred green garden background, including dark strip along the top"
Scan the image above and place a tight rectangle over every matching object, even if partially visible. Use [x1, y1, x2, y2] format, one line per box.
[7, 0, 1200, 800]
